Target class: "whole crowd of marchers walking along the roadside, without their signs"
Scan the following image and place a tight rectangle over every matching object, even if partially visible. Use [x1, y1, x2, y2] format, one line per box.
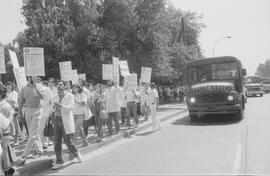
[0, 77, 161, 175]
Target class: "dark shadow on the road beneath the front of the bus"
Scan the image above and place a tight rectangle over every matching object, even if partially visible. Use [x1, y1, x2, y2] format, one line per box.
[172, 115, 239, 126]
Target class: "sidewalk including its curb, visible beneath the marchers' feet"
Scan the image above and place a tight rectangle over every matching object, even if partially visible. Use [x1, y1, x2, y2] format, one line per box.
[14, 104, 186, 175]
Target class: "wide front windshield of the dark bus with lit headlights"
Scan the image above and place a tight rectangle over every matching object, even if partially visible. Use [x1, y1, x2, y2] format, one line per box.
[189, 63, 239, 82]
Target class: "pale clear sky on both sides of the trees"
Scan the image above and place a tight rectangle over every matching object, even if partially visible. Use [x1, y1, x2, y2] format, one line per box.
[0, 0, 270, 75]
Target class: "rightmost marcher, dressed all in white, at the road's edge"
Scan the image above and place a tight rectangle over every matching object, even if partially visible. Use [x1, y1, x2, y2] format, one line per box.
[147, 83, 161, 131]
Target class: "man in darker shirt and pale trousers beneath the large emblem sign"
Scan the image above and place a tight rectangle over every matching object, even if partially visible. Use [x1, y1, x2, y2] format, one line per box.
[18, 77, 45, 164]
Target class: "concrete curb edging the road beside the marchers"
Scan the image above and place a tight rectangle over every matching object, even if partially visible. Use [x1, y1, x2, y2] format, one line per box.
[14, 109, 187, 175]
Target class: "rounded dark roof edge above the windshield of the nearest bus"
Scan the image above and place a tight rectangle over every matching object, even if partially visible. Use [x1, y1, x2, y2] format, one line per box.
[188, 56, 240, 66]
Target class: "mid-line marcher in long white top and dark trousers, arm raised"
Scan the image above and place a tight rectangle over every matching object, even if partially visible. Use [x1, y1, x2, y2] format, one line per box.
[105, 81, 122, 135]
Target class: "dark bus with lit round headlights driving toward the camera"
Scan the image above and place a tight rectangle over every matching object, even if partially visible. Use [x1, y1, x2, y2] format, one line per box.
[184, 56, 247, 121]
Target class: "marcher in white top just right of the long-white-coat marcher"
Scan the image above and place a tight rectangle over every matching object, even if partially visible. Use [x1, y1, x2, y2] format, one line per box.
[72, 84, 88, 147]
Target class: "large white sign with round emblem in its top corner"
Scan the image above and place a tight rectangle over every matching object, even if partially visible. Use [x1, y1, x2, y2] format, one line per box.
[23, 47, 45, 76]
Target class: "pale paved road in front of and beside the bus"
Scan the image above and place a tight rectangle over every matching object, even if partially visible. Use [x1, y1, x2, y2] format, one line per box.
[43, 95, 270, 175]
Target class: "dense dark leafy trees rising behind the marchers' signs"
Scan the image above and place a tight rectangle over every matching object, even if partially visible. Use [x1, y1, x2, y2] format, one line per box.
[0, 0, 204, 83]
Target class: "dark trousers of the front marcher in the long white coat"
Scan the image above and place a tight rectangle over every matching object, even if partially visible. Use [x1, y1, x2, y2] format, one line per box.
[54, 116, 78, 164]
